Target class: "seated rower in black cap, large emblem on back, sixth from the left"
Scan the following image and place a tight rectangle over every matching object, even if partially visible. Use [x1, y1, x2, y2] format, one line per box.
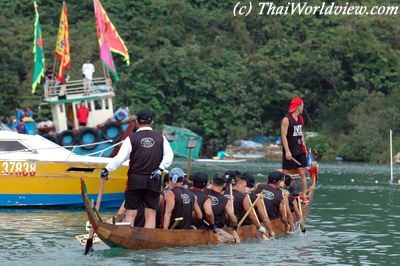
[256, 172, 294, 231]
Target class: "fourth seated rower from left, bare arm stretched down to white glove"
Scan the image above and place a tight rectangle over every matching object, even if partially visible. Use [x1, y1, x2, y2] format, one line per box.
[225, 171, 267, 234]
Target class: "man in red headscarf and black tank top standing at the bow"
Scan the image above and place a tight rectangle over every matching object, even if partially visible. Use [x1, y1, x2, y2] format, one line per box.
[281, 97, 309, 203]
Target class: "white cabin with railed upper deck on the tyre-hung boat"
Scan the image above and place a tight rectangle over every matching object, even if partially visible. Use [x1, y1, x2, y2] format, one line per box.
[44, 77, 115, 133]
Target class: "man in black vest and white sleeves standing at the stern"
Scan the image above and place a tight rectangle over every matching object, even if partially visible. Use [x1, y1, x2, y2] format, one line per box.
[101, 110, 174, 228]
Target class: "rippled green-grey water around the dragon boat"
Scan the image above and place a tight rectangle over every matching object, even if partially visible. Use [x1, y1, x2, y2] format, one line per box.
[0, 162, 400, 265]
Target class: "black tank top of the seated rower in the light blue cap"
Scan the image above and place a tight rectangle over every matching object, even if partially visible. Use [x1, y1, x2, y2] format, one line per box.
[170, 187, 194, 229]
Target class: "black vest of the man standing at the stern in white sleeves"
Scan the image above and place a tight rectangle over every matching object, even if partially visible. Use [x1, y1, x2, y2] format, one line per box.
[127, 130, 164, 192]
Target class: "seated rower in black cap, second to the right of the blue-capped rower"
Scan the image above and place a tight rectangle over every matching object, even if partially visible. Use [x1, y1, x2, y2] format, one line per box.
[204, 173, 237, 228]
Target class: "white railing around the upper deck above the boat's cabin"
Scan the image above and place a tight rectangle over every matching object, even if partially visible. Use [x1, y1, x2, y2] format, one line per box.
[44, 77, 114, 101]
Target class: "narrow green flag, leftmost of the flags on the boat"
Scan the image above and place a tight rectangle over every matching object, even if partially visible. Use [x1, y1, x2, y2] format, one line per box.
[32, 1, 44, 94]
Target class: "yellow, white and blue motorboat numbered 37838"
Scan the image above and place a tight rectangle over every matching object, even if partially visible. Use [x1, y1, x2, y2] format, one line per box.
[0, 130, 127, 208]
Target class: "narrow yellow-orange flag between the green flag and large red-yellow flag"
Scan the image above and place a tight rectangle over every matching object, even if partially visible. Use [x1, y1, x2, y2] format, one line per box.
[55, 2, 71, 81]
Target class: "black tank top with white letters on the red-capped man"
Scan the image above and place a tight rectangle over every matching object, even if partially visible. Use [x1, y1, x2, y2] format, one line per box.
[282, 114, 306, 155]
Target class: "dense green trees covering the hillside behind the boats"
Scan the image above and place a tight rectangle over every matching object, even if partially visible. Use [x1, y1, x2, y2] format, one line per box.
[0, 0, 400, 161]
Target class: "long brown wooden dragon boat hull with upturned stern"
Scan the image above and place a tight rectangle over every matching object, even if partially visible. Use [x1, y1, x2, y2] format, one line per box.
[81, 179, 310, 249]
